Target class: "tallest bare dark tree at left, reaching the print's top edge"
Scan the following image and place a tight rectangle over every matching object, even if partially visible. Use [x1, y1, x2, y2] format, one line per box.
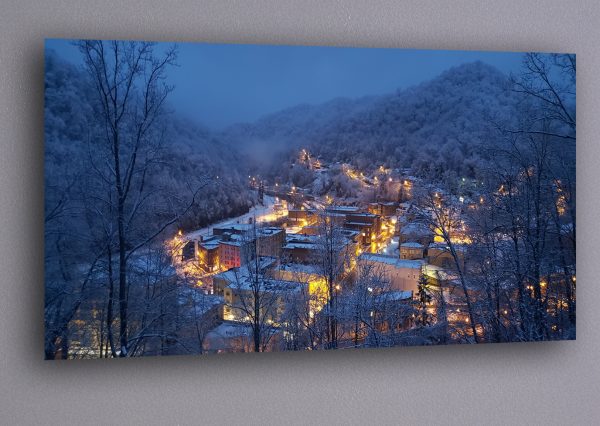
[77, 40, 197, 356]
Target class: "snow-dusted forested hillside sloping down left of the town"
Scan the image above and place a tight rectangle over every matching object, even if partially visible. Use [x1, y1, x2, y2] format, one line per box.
[44, 52, 253, 233]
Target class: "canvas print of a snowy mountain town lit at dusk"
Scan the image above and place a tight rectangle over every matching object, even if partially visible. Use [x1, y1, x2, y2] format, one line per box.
[44, 39, 576, 359]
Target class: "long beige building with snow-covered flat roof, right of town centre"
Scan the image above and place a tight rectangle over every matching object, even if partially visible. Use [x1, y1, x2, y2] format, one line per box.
[358, 253, 425, 296]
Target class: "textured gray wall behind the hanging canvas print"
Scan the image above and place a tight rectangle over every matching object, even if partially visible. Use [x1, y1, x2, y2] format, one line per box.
[0, 0, 600, 424]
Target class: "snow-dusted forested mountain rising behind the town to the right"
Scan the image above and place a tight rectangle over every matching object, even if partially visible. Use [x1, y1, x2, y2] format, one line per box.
[223, 62, 517, 179]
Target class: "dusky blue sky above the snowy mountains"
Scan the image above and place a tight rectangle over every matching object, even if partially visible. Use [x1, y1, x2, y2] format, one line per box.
[46, 39, 522, 129]
